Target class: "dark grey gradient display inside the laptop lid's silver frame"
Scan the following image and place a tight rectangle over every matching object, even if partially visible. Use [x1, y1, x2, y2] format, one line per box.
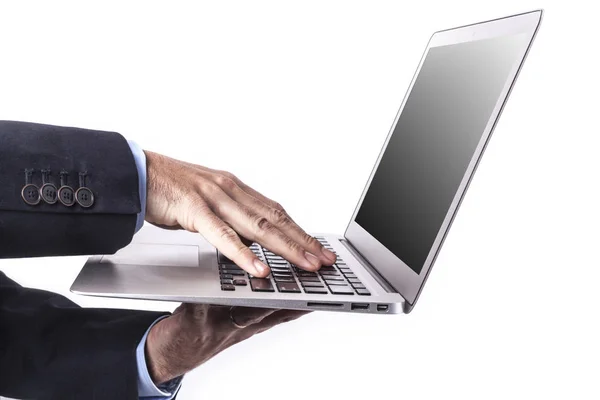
[355, 34, 527, 274]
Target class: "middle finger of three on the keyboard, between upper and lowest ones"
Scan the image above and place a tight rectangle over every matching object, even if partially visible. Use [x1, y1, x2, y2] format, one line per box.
[214, 195, 321, 271]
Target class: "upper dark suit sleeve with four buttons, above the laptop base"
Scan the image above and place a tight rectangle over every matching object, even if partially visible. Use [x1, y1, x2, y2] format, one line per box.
[0, 121, 141, 258]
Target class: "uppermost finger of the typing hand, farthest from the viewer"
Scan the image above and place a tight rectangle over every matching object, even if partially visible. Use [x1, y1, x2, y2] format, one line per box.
[217, 185, 336, 265]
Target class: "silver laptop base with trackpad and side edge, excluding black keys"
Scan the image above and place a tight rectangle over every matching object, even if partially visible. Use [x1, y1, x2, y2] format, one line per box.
[71, 226, 404, 314]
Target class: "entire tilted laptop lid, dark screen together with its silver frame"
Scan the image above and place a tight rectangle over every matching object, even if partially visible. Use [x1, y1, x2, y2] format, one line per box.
[344, 10, 542, 313]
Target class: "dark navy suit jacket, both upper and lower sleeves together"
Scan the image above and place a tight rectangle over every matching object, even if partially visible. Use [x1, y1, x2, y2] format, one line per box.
[0, 121, 169, 400]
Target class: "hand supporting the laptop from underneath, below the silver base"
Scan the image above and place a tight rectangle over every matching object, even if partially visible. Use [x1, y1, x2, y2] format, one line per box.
[146, 304, 307, 385]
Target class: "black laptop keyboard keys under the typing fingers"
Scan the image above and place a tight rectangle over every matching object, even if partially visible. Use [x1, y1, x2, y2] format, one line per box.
[218, 236, 371, 296]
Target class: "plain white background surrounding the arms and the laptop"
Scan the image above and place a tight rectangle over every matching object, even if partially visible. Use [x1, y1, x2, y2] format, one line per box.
[0, 0, 600, 400]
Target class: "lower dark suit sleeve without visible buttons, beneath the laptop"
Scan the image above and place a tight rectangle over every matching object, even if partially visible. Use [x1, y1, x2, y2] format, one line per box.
[0, 272, 165, 400]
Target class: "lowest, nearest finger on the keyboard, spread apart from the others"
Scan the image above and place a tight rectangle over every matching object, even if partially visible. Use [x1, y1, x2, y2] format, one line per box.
[192, 200, 269, 277]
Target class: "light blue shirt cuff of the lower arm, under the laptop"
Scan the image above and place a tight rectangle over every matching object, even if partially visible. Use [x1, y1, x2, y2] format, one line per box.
[135, 315, 183, 400]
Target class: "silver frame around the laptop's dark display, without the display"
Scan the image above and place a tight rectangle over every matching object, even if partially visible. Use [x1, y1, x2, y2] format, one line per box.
[344, 10, 542, 307]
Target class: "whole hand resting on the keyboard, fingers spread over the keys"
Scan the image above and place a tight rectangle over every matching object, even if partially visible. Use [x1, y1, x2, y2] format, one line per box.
[146, 151, 336, 277]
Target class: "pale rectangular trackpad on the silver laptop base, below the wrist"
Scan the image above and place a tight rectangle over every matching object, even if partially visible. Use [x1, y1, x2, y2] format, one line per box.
[100, 243, 199, 267]
